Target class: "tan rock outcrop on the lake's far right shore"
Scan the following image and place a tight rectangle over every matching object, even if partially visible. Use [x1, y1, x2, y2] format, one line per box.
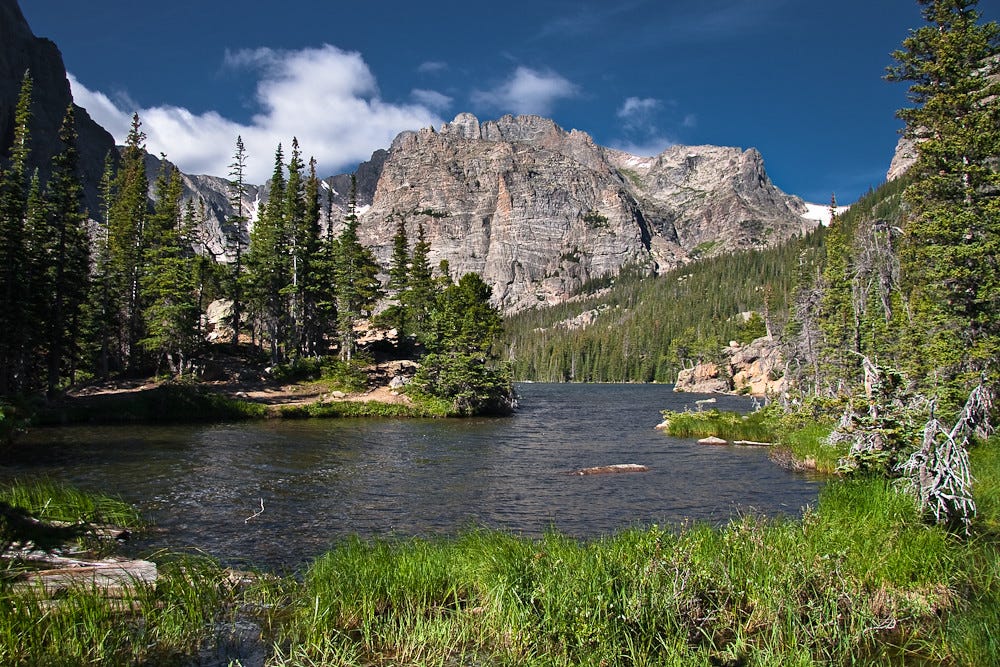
[674, 337, 788, 396]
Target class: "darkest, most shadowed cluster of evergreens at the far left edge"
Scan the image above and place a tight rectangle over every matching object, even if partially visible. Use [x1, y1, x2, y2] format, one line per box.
[0, 73, 90, 395]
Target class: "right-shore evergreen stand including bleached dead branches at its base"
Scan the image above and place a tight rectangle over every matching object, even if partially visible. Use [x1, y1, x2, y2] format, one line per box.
[790, 0, 1000, 531]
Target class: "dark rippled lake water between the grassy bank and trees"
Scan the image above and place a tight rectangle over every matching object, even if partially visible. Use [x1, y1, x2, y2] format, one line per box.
[0, 384, 820, 571]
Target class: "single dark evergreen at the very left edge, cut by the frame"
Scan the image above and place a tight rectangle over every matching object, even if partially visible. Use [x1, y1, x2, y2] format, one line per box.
[0, 72, 33, 396]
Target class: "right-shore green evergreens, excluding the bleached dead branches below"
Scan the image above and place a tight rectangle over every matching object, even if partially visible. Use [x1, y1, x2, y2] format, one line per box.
[796, 0, 1000, 411]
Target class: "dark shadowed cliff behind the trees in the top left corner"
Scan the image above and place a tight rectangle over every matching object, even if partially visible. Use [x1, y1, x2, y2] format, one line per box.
[0, 0, 115, 212]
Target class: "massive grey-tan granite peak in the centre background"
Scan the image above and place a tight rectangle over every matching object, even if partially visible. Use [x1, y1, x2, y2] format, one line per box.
[361, 114, 815, 311]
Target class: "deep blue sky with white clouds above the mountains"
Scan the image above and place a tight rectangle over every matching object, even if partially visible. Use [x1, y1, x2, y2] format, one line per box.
[21, 0, 1000, 203]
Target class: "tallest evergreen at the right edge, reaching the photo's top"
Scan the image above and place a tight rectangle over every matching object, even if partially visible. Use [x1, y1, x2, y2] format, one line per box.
[887, 0, 1000, 409]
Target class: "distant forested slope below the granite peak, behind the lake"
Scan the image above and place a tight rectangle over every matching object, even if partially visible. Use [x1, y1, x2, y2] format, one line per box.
[507, 229, 826, 382]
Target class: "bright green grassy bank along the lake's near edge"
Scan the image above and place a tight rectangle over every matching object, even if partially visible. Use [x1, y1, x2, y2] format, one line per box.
[0, 440, 1000, 665]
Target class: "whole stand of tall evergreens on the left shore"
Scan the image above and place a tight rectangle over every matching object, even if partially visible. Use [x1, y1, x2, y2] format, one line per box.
[0, 85, 511, 413]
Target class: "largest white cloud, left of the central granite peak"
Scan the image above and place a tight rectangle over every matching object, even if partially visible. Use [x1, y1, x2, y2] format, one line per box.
[70, 45, 446, 183]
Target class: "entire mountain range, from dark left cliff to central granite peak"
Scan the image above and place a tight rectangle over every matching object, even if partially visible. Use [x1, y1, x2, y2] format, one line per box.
[0, 0, 818, 312]
